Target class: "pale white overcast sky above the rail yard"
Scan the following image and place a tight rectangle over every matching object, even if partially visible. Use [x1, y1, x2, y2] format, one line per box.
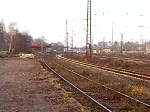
[0, 0, 150, 46]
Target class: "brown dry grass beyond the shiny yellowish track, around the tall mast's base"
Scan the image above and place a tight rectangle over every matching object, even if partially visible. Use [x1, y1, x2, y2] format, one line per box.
[68, 55, 150, 74]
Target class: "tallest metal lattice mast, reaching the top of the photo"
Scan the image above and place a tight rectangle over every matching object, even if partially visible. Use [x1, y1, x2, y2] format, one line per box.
[86, 0, 92, 59]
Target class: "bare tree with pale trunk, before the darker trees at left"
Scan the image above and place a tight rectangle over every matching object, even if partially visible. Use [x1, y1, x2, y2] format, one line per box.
[5, 23, 18, 52]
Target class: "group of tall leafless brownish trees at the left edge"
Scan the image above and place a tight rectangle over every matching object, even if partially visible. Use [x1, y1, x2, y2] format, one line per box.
[0, 20, 33, 53]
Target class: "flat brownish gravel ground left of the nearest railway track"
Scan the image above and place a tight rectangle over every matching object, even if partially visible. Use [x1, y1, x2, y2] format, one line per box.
[0, 59, 86, 112]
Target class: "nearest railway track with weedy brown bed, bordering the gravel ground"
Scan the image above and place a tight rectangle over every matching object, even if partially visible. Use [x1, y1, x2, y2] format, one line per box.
[44, 61, 150, 112]
